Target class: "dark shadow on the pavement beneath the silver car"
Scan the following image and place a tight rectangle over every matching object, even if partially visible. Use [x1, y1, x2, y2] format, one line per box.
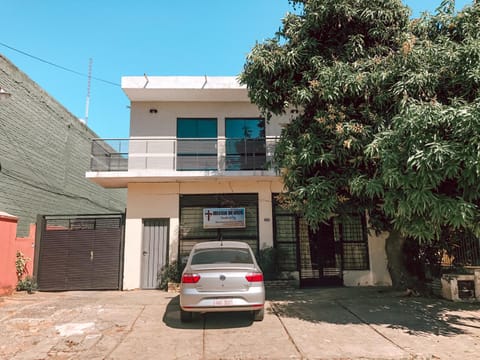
[163, 295, 253, 330]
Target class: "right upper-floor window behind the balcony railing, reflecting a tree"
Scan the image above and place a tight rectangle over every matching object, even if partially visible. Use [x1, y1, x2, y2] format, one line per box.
[225, 118, 266, 170]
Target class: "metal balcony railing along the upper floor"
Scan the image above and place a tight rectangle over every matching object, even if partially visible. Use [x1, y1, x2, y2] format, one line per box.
[90, 137, 278, 171]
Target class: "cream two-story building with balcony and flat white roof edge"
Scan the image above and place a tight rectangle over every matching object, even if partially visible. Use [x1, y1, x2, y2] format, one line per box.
[87, 76, 391, 289]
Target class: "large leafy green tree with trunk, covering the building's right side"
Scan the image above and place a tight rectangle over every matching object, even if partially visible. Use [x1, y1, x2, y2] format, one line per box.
[240, 0, 480, 285]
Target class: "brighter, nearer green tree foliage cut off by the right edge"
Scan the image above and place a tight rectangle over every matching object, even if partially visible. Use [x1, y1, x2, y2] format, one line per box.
[364, 1, 480, 255]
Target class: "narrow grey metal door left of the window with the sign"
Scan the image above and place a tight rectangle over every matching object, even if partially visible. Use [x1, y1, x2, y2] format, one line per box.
[141, 219, 169, 289]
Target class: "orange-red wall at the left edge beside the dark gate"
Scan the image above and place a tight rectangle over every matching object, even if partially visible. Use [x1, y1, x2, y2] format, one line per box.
[0, 213, 35, 296]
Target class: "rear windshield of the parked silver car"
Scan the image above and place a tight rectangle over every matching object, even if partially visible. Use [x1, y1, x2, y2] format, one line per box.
[191, 248, 253, 265]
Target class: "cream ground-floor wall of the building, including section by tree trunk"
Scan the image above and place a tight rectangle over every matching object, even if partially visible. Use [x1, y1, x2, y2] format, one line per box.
[123, 179, 392, 289]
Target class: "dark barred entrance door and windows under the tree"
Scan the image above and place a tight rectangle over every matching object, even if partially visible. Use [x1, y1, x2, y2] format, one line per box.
[272, 194, 370, 286]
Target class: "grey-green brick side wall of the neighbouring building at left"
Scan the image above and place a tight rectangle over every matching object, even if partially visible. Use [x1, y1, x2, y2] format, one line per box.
[0, 55, 126, 236]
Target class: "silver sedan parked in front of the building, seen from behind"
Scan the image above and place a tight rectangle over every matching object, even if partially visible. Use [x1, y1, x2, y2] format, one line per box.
[180, 241, 265, 321]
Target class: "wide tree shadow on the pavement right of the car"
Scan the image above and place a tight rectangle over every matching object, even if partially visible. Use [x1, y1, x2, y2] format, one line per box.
[267, 288, 480, 336]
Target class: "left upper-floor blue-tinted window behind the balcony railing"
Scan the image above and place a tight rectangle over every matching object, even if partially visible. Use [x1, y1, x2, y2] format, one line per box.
[176, 118, 217, 170]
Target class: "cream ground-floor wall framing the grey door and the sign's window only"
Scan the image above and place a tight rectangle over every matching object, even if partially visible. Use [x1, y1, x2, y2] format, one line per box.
[123, 181, 282, 289]
